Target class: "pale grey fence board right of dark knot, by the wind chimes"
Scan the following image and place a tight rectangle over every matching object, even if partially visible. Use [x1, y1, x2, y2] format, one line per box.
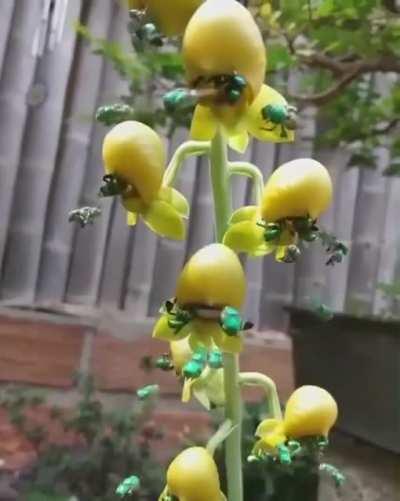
[3, 1, 81, 302]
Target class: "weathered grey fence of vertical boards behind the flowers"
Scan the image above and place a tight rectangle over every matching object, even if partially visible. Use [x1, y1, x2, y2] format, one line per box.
[0, 0, 400, 328]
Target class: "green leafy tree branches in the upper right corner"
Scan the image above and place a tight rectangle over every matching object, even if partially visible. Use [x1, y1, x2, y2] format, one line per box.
[249, 0, 400, 176]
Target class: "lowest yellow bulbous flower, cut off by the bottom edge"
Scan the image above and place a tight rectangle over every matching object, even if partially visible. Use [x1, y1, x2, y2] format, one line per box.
[159, 447, 226, 501]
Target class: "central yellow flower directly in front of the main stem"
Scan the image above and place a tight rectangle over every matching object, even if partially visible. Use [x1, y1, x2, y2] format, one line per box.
[153, 244, 246, 353]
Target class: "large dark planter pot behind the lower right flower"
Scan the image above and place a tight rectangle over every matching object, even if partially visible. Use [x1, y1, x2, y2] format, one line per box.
[288, 308, 400, 453]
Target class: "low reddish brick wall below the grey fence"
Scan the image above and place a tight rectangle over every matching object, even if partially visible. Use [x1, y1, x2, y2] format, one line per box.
[0, 309, 293, 469]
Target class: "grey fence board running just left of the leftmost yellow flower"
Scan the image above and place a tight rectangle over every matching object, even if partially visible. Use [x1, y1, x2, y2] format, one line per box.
[37, 2, 112, 303]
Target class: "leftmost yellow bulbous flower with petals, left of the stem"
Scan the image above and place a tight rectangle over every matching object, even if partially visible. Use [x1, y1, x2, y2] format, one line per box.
[103, 120, 189, 240]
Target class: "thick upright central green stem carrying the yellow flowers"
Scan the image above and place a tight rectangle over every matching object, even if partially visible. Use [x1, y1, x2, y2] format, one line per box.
[210, 132, 243, 501]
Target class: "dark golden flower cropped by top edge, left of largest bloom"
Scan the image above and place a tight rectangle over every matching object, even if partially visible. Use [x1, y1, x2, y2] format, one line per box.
[128, 0, 203, 37]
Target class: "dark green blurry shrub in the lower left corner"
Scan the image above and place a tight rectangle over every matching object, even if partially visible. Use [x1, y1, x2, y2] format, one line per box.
[0, 376, 161, 501]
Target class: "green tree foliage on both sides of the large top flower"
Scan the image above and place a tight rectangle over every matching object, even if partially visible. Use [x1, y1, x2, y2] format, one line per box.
[77, 0, 400, 172]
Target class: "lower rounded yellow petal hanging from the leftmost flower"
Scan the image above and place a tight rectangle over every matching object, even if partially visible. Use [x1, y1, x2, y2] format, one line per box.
[142, 200, 186, 240]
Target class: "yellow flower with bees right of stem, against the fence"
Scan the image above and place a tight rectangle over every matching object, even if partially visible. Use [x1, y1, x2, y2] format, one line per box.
[224, 158, 332, 263]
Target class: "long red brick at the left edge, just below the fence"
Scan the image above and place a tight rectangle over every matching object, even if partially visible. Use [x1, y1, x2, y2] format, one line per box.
[0, 315, 87, 388]
